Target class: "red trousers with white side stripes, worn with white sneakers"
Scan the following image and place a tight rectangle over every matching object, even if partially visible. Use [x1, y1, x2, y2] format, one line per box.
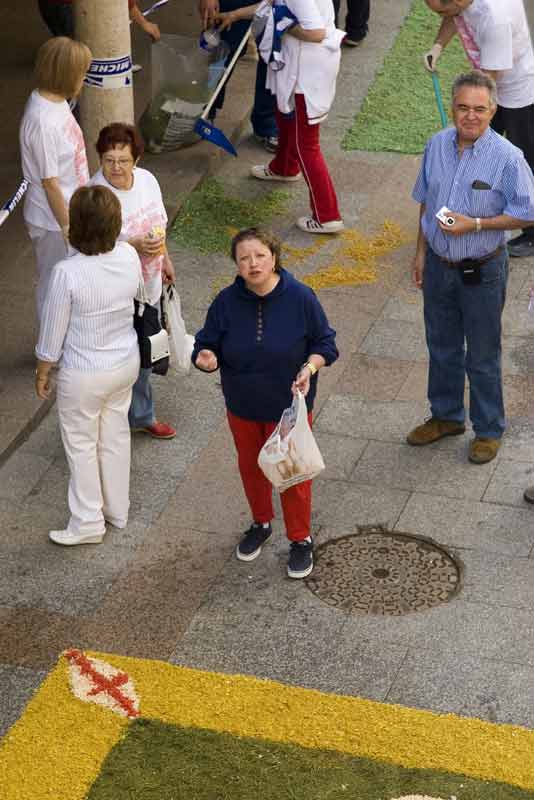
[269, 94, 341, 222]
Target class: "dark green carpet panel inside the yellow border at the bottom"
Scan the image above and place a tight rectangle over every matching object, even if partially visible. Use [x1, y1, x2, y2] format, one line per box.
[87, 719, 534, 800]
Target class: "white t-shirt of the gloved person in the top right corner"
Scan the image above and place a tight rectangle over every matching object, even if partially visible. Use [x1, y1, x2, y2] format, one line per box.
[455, 0, 534, 108]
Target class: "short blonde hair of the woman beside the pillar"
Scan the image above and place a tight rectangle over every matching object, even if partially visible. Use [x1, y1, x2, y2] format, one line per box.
[35, 36, 92, 98]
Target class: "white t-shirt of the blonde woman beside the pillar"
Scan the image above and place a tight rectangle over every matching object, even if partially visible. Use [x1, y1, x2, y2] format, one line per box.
[19, 90, 89, 231]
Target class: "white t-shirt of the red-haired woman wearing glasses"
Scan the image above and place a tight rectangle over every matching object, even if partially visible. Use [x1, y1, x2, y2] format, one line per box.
[89, 167, 167, 305]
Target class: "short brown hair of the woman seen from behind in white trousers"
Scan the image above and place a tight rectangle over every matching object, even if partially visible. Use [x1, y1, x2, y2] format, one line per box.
[69, 186, 122, 256]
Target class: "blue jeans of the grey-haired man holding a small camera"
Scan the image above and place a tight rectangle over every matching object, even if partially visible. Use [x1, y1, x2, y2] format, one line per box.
[423, 247, 508, 439]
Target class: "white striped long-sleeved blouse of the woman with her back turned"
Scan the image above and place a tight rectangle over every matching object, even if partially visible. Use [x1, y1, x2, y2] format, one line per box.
[35, 242, 142, 372]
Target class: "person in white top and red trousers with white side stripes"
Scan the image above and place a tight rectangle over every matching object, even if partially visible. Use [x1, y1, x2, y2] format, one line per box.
[219, 0, 344, 233]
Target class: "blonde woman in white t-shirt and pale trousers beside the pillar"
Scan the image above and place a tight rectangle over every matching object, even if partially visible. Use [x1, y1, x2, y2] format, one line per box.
[19, 36, 91, 318]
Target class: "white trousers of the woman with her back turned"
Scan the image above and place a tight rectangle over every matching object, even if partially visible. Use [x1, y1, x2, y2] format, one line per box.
[57, 353, 139, 533]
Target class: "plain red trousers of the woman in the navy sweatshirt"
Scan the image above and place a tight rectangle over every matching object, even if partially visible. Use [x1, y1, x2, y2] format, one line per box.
[227, 411, 312, 542]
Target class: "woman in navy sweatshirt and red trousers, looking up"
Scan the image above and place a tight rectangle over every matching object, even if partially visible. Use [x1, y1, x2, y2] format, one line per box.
[192, 228, 338, 578]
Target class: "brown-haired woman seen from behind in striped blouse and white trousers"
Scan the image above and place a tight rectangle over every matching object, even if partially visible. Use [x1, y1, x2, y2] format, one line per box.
[35, 186, 143, 545]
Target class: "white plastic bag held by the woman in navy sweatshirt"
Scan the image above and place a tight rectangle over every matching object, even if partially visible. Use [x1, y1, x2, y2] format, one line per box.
[258, 392, 325, 492]
